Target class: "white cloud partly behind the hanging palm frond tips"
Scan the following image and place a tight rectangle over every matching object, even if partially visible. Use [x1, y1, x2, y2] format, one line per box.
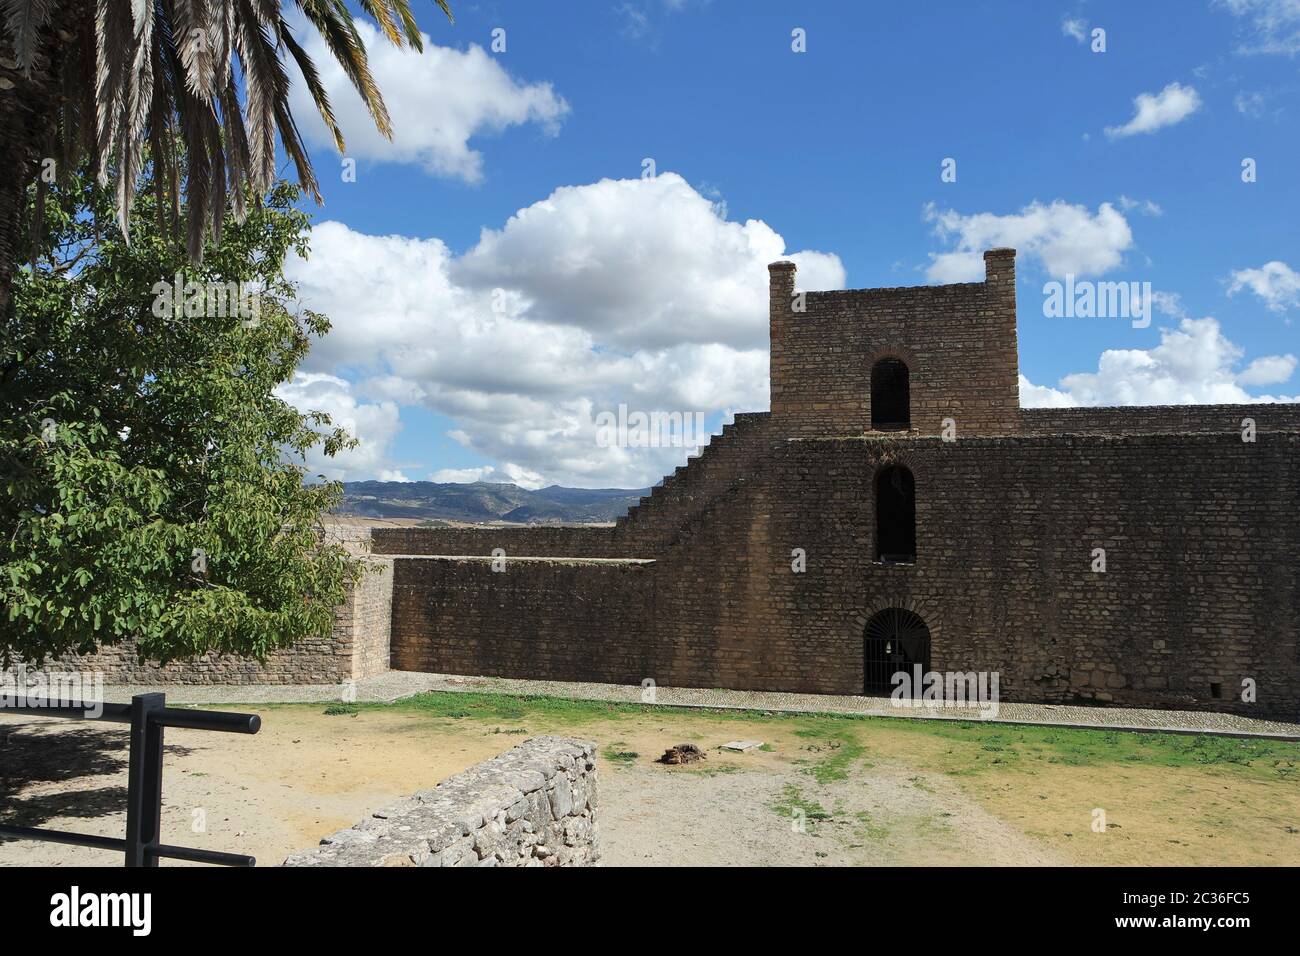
[290, 14, 568, 182]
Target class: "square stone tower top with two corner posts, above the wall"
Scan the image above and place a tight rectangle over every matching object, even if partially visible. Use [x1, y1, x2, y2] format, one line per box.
[768, 248, 1019, 437]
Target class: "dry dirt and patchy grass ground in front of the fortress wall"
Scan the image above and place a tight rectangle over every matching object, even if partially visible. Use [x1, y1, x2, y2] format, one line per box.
[0, 693, 1300, 865]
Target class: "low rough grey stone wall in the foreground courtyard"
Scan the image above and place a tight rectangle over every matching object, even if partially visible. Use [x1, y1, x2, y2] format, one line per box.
[283, 736, 599, 866]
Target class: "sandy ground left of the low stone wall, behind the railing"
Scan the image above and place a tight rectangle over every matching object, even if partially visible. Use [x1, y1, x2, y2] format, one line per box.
[0, 708, 499, 866]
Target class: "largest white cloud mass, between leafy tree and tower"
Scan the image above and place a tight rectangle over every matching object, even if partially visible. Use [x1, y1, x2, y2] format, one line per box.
[287, 173, 845, 486]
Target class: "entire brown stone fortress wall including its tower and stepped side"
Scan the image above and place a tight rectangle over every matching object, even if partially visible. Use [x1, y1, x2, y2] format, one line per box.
[48, 250, 1300, 719]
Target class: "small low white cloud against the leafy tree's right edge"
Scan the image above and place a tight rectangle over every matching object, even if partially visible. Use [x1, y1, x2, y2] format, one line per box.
[276, 372, 410, 481]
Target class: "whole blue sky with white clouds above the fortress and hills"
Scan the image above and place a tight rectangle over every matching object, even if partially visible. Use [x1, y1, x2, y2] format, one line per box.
[276, 0, 1300, 486]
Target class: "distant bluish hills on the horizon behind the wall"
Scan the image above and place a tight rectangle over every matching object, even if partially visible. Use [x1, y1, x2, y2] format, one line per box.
[335, 481, 650, 524]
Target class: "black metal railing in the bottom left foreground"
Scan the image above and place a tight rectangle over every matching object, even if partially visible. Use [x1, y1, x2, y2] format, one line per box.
[0, 693, 261, 866]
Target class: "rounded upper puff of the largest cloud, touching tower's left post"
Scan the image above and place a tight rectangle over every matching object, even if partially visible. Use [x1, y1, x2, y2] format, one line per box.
[451, 173, 844, 347]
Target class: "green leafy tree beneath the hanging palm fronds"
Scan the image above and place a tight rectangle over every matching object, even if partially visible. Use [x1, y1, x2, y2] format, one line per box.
[0, 164, 359, 662]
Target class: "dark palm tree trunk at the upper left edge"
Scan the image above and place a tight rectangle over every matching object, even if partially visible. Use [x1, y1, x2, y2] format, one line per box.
[0, 0, 76, 323]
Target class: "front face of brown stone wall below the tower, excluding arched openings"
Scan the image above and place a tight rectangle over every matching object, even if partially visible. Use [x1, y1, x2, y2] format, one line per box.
[382, 433, 1300, 717]
